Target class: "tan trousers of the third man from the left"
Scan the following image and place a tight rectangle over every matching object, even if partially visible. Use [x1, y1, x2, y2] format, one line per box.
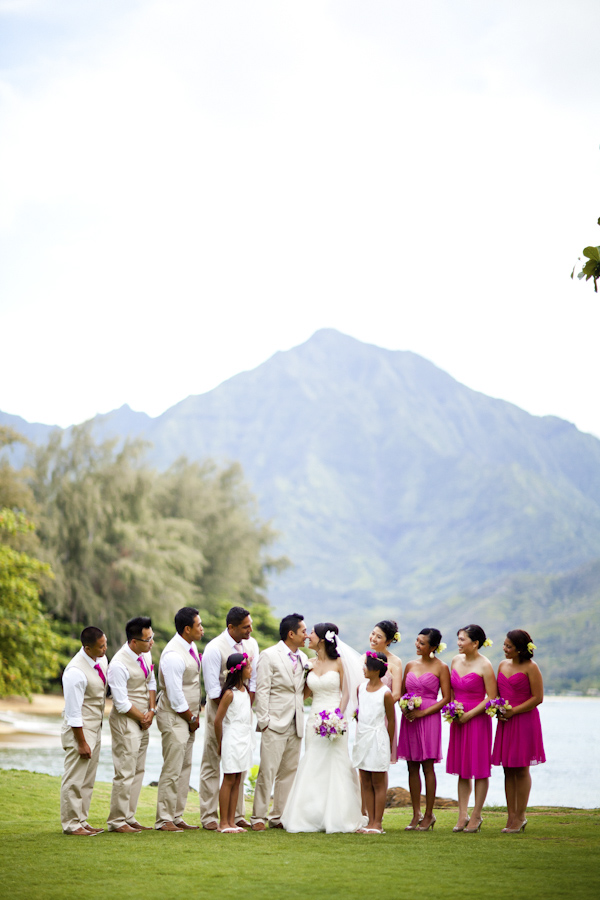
[154, 710, 196, 828]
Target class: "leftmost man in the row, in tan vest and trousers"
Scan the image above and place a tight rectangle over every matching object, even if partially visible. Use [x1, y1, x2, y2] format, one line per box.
[60, 625, 107, 837]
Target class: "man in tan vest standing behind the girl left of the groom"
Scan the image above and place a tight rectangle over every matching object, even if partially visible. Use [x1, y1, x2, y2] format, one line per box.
[200, 606, 259, 831]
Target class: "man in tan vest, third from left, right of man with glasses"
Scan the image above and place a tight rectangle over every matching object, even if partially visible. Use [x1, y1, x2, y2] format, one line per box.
[154, 606, 204, 831]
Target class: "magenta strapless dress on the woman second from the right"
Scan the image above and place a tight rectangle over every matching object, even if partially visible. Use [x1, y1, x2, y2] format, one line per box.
[446, 669, 492, 778]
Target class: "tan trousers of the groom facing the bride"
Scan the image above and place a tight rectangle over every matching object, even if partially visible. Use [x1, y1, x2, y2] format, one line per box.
[252, 718, 302, 828]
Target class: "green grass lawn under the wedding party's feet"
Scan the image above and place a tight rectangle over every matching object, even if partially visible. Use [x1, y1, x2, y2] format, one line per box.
[0, 770, 600, 900]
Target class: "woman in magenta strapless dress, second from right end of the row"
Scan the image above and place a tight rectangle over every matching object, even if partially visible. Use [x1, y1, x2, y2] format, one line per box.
[446, 625, 497, 834]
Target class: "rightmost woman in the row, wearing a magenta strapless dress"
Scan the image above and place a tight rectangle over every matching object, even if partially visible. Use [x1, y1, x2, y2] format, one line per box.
[492, 629, 546, 834]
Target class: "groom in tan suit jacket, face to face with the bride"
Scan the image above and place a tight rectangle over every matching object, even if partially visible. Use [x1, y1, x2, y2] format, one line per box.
[252, 613, 308, 831]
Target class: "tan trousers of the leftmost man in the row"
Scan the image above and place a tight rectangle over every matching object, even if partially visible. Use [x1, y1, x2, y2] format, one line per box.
[60, 724, 102, 834]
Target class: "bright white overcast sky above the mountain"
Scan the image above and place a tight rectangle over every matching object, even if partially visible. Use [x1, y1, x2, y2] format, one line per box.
[0, 0, 600, 436]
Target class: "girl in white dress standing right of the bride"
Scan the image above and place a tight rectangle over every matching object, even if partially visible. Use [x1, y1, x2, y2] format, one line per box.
[352, 651, 396, 834]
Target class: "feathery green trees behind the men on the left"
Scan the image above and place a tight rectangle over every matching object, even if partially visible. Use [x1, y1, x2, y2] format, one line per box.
[0, 423, 289, 695]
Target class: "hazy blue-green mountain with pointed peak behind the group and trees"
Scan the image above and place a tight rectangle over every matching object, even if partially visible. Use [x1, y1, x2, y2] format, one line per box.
[0, 329, 600, 676]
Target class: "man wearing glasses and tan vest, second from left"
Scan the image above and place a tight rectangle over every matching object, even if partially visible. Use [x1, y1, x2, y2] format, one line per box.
[107, 616, 156, 834]
